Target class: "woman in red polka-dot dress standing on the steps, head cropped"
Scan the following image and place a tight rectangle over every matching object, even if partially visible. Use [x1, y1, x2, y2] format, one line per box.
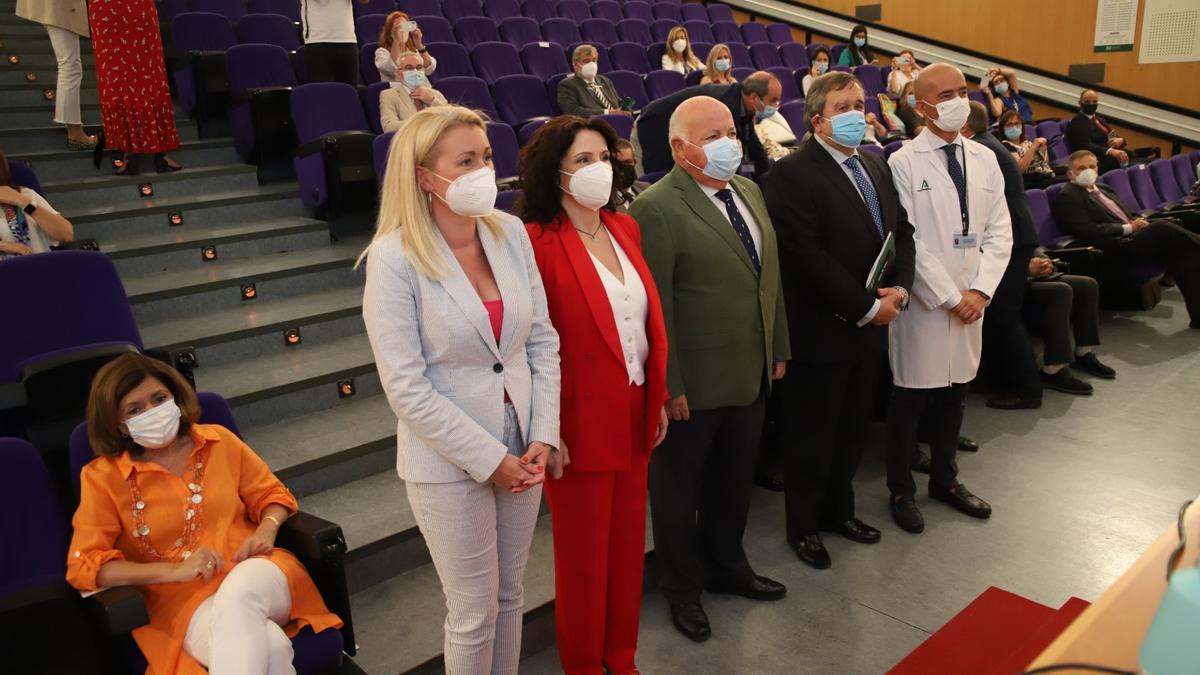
[88, 0, 182, 174]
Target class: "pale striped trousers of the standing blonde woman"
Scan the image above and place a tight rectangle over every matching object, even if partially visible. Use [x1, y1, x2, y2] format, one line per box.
[407, 406, 541, 675]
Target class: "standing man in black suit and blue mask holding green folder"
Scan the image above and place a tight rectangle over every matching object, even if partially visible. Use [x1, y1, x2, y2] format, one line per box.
[763, 72, 914, 569]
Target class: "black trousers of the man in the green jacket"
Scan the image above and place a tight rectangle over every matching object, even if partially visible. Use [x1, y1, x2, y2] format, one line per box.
[649, 394, 764, 603]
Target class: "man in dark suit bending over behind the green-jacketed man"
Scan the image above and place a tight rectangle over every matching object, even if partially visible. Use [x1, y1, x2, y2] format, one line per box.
[634, 71, 784, 178]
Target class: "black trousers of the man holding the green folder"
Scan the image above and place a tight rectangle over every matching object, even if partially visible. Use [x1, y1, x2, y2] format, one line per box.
[778, 354, 882, 542]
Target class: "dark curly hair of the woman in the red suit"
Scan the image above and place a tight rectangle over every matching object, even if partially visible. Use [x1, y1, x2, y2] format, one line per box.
[515, 115, 620, 226]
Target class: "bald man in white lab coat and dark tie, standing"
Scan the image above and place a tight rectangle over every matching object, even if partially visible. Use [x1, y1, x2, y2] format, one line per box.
[887, 64, 1013, 533]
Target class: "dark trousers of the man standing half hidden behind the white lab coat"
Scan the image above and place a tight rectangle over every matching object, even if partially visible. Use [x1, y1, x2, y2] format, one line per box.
[983, 243, 1042, 399]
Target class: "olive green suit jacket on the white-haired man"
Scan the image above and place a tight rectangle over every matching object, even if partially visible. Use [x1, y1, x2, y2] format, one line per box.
[629, 166, 791, 410]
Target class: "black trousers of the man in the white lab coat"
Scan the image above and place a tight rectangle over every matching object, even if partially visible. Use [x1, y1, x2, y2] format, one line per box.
[884, 383, 967, 497]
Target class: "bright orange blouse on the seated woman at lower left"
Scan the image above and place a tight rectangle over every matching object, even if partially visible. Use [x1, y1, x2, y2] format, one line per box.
[67, 424, 342, 675]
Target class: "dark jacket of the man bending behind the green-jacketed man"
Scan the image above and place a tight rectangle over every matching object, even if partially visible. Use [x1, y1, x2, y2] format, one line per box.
[638, 80, 770, 177]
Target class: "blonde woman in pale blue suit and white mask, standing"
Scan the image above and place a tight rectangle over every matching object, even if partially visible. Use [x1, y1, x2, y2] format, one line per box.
[362, 106, 559, 675]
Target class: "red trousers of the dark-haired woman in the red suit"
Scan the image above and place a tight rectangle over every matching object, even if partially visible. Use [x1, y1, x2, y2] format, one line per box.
[546, 387, 658, 675]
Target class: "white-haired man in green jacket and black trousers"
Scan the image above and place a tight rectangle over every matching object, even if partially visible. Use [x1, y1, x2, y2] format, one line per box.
[630, 96, 790, 641]
